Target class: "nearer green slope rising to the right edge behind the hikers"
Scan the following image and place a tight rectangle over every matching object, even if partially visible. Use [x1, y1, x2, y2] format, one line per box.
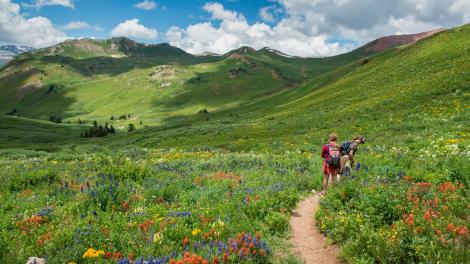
[130, 25, 470, 149]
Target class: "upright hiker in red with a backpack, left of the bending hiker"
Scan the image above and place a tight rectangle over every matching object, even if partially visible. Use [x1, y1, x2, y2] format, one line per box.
[320, 133, 341, 196]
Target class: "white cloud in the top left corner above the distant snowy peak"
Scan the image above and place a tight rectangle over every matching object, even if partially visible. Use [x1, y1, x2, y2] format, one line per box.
[0, 0, 67, 48]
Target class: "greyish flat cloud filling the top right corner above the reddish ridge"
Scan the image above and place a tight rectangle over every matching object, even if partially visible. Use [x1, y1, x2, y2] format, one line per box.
[276, 0, 470, 42]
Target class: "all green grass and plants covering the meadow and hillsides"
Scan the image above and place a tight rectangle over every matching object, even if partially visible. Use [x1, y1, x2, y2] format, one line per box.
[0, 25, 470, 263]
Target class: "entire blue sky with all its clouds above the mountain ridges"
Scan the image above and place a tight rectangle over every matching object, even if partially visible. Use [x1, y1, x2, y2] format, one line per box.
[0, 0, 470, 57]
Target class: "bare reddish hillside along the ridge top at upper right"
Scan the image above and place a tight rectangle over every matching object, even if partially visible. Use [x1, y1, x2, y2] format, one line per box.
[363, 28, 445, 52]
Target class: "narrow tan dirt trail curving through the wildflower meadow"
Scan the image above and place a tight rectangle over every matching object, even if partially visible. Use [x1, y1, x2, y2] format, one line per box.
[290, 195, 340, 264]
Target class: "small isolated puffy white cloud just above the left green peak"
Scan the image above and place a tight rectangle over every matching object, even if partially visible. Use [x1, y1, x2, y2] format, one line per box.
[111, 18, 158, 40]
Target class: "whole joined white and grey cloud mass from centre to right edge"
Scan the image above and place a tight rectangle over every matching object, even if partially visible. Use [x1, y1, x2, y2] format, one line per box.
[166, 0, 470, 57]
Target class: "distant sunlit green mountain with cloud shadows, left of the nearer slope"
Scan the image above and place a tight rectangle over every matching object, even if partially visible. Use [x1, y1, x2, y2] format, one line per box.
[0, 38, 368, 125]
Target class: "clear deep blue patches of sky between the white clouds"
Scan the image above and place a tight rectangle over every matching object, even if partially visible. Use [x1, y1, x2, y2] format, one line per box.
[22, 0, 280, 42]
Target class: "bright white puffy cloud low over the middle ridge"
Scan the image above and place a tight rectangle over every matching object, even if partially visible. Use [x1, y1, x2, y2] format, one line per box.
[166, 3, 344, 56]
